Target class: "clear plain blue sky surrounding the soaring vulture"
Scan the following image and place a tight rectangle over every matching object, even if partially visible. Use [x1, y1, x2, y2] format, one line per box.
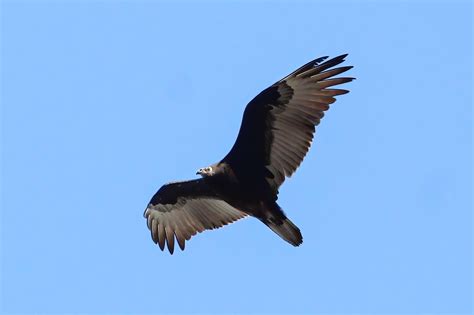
[0, 0, 473, 314]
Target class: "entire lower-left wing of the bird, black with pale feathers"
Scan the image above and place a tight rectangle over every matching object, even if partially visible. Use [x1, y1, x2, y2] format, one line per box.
[144, 179, 246, 254]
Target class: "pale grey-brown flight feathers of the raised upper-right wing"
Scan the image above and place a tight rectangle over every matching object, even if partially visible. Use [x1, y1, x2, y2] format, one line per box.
[266, 55, 353, 190]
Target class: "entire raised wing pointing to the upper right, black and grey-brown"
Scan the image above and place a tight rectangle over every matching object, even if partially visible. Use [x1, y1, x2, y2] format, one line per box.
[223, 55, 353, 194]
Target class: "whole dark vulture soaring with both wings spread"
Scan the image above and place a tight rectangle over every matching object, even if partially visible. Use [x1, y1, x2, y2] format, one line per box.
[144, 54, 354, 254]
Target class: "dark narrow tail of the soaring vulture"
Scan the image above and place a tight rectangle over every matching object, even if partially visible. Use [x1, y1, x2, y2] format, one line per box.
[261, 205, 303, 246]
